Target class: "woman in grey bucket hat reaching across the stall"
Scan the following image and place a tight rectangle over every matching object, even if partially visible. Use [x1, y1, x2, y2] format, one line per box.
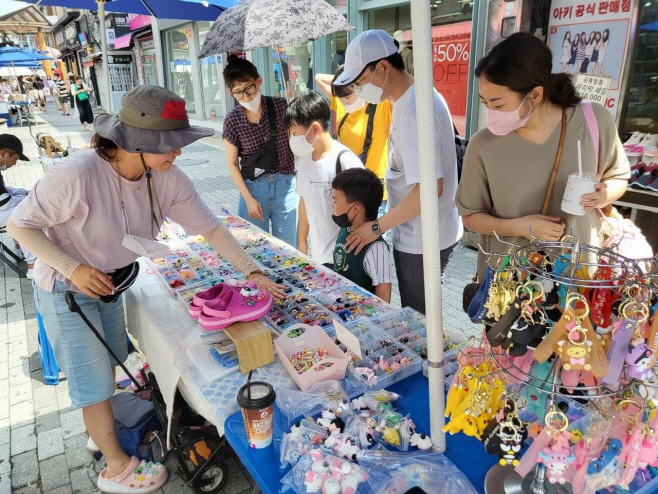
[8, 86, 283, 493]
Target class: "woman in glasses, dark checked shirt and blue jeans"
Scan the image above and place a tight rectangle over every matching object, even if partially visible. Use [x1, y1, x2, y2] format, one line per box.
[223, 55, 299, 247]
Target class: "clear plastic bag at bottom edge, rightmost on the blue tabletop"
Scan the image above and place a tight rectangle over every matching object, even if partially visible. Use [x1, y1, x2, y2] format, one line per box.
[358, 449, 477, 494]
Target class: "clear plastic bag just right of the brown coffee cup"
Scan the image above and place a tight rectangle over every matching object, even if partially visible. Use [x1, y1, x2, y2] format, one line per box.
[276, 381, 349, 422]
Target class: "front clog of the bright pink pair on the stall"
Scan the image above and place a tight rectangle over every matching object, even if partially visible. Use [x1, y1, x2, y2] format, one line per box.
[199, 283, 272, 331]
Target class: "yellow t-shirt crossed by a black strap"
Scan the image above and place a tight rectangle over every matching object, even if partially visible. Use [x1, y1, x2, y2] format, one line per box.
[331, 96, 393, 200]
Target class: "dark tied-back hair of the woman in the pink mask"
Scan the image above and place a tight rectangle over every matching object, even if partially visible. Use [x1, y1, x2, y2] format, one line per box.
[475, 33, 581, 108]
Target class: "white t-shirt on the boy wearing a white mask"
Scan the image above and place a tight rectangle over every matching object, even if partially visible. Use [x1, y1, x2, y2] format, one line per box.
[297, 141, 363, 264]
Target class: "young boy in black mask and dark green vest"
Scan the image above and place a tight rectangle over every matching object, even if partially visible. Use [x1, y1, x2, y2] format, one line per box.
[331, 168, 391, 302]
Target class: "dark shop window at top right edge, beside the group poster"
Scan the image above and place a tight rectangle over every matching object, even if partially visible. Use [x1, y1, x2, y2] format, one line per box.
[622, 1, 658, 133]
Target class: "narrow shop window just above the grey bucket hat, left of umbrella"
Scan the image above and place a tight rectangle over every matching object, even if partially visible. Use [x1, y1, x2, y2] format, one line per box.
[165, 24, 196, 113]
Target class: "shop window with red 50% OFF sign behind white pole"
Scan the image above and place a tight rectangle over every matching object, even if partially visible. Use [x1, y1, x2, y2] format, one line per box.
[368, 0, 473, 135]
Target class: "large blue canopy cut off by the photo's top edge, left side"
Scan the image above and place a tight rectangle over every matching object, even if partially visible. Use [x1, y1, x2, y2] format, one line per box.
[26, 0, 238, 21]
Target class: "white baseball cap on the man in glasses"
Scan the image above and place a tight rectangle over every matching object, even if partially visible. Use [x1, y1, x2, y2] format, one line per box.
[333, 29, 398, 86]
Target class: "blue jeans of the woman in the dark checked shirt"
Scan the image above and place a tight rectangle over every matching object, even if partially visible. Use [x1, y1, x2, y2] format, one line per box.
[238, 173, 299, 248]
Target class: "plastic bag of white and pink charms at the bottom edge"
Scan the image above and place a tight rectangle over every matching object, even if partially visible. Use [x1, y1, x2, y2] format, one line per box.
[281, 449, 368, 494]
